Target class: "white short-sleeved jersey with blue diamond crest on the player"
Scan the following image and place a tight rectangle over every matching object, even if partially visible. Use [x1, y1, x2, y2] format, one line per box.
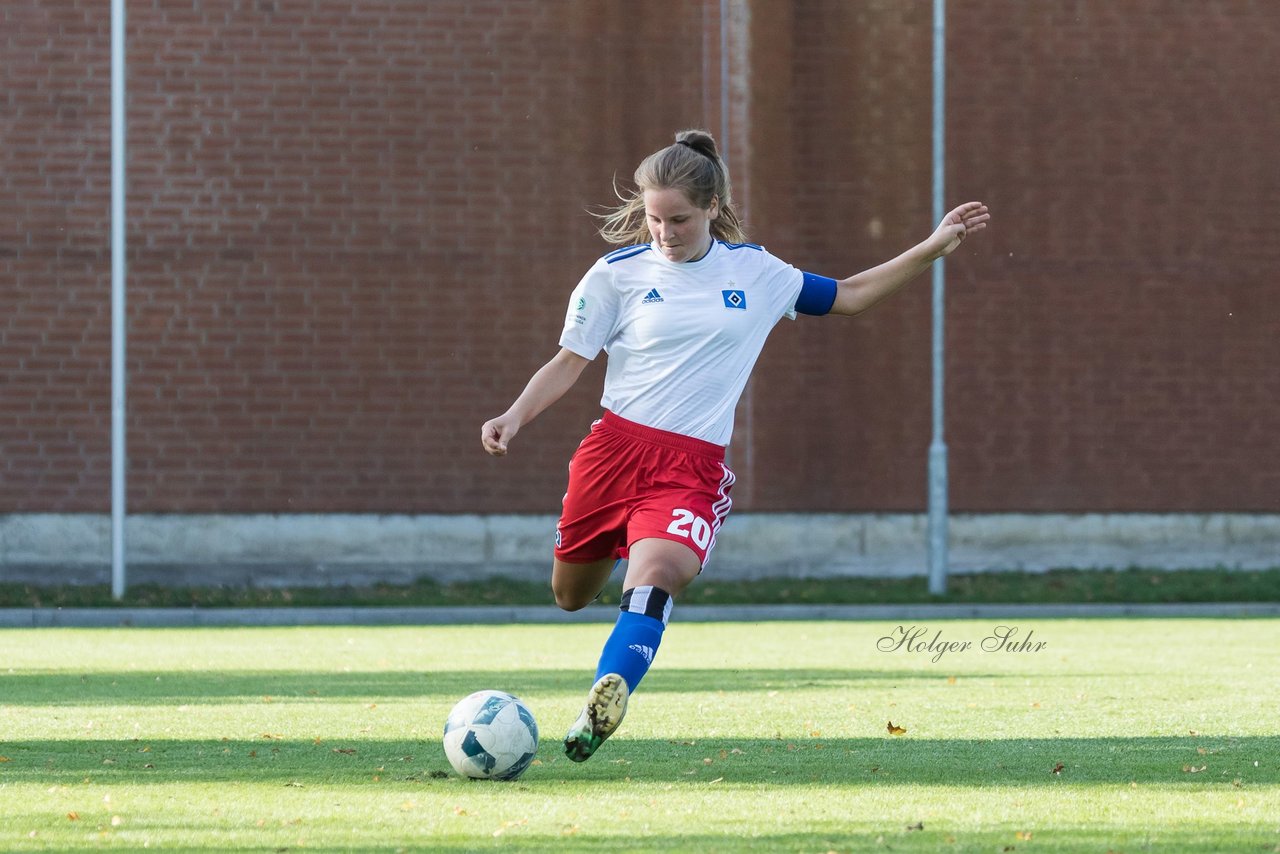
[559, 241, 804, 444]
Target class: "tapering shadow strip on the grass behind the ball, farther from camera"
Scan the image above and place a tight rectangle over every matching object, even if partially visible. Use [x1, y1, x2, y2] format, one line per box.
[0, 668, 1012, 705]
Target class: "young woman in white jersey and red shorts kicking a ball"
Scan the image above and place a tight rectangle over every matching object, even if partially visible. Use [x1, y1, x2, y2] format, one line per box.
[480, 131, 989, 762]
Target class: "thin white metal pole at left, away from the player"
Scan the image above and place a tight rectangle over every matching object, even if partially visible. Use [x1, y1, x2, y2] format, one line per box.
[111, 0, 125, 599]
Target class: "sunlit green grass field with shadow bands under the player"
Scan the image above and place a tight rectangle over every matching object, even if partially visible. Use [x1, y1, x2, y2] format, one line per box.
[0, 609, 1280, 853]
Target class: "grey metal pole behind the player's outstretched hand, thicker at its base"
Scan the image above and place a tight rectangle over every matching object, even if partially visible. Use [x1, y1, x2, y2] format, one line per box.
[929, 0, 947, 595]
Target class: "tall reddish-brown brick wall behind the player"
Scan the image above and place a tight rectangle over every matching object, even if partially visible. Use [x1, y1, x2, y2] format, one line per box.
[0, 0, 1280, 512]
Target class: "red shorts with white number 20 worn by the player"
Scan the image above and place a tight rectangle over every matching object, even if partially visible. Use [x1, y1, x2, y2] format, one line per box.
[556, 411, 735, 565]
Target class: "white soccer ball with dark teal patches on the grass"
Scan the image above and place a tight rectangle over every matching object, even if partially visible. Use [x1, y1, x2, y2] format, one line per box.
[444, 691, 538, 780]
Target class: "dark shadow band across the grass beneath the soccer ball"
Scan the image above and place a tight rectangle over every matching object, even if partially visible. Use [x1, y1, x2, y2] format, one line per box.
[0, 734, 1280, 793]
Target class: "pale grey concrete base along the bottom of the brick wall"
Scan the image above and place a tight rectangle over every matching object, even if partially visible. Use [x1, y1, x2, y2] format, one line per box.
[0, 513, 1280, 586]
